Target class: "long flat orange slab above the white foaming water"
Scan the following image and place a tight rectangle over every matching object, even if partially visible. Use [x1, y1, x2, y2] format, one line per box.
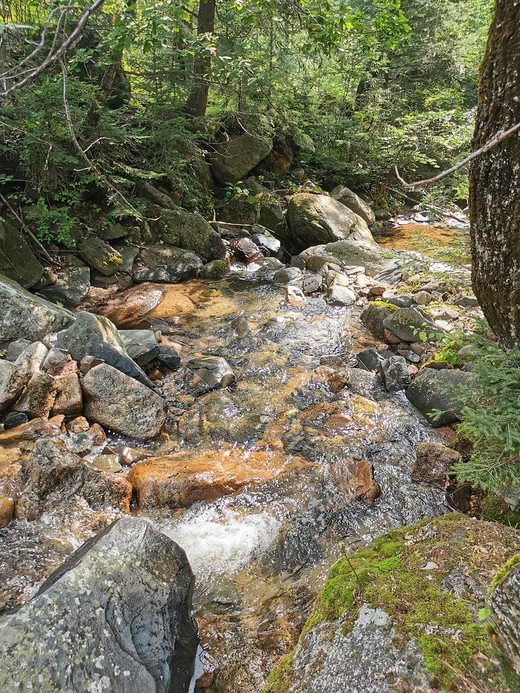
[127, 448, 310, 509]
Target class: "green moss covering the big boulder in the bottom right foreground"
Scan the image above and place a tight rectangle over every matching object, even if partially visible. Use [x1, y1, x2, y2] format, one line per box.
[264, 515, 520, 693]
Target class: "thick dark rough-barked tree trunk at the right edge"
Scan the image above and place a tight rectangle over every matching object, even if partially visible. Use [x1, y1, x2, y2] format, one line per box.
[469, 0, 520, 347]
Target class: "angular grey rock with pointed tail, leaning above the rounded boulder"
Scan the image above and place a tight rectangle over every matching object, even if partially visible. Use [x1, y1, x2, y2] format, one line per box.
[57, 311, 153, 388]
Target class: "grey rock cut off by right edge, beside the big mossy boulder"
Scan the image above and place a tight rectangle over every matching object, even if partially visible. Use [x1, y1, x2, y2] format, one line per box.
[488, 554, 520, 676]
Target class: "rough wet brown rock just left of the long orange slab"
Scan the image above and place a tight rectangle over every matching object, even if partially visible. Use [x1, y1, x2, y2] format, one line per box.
[15, 438, 132, 520]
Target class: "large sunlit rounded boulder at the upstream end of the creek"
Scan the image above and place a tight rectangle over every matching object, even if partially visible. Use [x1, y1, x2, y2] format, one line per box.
[287, 193, 374, 251]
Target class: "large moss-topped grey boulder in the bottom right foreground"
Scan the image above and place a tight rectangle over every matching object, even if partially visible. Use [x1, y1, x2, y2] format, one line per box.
[264, 514, 520, 693]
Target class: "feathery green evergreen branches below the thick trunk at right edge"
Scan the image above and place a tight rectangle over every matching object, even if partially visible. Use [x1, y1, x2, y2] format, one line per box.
[453, 341, 520, 495]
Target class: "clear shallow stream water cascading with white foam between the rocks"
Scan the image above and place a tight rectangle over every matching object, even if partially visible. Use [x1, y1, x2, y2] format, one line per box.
[0, 262, 446, 693]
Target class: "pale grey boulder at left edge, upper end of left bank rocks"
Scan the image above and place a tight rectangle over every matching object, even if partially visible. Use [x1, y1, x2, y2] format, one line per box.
[0, 275, 75, 342]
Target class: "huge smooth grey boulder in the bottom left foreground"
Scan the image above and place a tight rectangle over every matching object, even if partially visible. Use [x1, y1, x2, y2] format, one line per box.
[0, 518, 197, 693]
